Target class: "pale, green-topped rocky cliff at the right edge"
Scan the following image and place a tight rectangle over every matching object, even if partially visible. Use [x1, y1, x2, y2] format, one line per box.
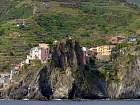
[108, 46, 140, 99]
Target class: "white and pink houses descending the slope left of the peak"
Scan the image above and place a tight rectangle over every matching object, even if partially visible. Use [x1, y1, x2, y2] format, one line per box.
[0, 43, 51, 89]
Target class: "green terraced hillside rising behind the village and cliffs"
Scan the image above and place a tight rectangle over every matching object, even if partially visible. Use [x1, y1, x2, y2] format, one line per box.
[0, 0, 140, 71]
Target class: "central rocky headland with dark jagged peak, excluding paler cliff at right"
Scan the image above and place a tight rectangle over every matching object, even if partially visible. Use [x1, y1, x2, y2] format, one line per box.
[7, 39, 108, 100]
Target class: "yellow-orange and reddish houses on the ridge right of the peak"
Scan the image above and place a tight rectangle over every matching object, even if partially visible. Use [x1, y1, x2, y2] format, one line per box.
[83, 35, 138, 61]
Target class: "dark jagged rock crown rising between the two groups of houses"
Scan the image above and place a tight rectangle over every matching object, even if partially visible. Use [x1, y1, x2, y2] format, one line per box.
[52, 39, 84, 69]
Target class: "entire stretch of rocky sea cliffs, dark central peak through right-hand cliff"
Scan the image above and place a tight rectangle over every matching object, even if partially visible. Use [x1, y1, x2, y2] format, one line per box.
[4, 39, 140, 100]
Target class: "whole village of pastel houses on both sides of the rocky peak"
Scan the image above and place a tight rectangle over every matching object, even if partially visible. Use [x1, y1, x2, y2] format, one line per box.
[0, 35, 138, 96]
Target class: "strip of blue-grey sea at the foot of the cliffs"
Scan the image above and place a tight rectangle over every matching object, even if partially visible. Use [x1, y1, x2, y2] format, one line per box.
[0, 100, 140, 105]
